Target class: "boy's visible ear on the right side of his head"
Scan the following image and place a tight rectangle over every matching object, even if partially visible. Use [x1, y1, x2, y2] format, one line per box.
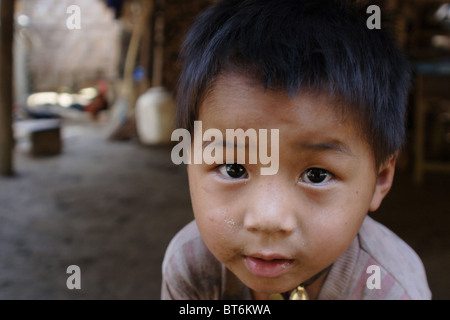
[369, 154, 398, 212]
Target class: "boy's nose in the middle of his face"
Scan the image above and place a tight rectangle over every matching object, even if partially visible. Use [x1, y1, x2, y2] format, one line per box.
[244, 184, 297, 237]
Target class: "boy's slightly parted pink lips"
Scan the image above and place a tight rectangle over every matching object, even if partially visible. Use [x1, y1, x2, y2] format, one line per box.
[244, 255, 294, 278]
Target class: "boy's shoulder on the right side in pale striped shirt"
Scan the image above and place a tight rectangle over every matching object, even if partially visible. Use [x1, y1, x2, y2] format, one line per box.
[319, 216, 431, 300]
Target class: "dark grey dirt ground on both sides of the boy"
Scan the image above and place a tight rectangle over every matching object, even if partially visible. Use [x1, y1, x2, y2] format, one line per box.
[0, 109, 450, 299]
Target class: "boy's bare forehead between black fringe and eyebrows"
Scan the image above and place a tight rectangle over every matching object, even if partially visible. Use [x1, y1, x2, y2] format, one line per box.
[199, 74, 366, 154]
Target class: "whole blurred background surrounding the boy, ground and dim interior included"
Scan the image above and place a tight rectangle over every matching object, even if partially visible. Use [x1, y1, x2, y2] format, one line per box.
[0, 0, 450, 299]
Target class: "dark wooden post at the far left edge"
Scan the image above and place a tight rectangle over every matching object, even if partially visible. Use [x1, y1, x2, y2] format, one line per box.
[0, 0, 14, 176]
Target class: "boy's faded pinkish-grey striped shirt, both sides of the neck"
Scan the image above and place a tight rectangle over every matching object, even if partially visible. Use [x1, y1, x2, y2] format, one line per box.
[161, 216, 431, 300]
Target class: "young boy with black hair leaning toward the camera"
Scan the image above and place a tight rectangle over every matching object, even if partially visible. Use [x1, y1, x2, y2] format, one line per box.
[161, 0, 431, 299]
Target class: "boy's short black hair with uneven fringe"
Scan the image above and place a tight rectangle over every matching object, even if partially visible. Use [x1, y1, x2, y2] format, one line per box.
[176, 0, 411, 167]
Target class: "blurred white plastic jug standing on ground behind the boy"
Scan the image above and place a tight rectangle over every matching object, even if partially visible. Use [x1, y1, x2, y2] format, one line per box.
[135, 87, 175, 145]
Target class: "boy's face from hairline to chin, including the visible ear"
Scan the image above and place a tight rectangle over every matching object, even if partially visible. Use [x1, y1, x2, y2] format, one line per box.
[188, 74, 395, 294]
